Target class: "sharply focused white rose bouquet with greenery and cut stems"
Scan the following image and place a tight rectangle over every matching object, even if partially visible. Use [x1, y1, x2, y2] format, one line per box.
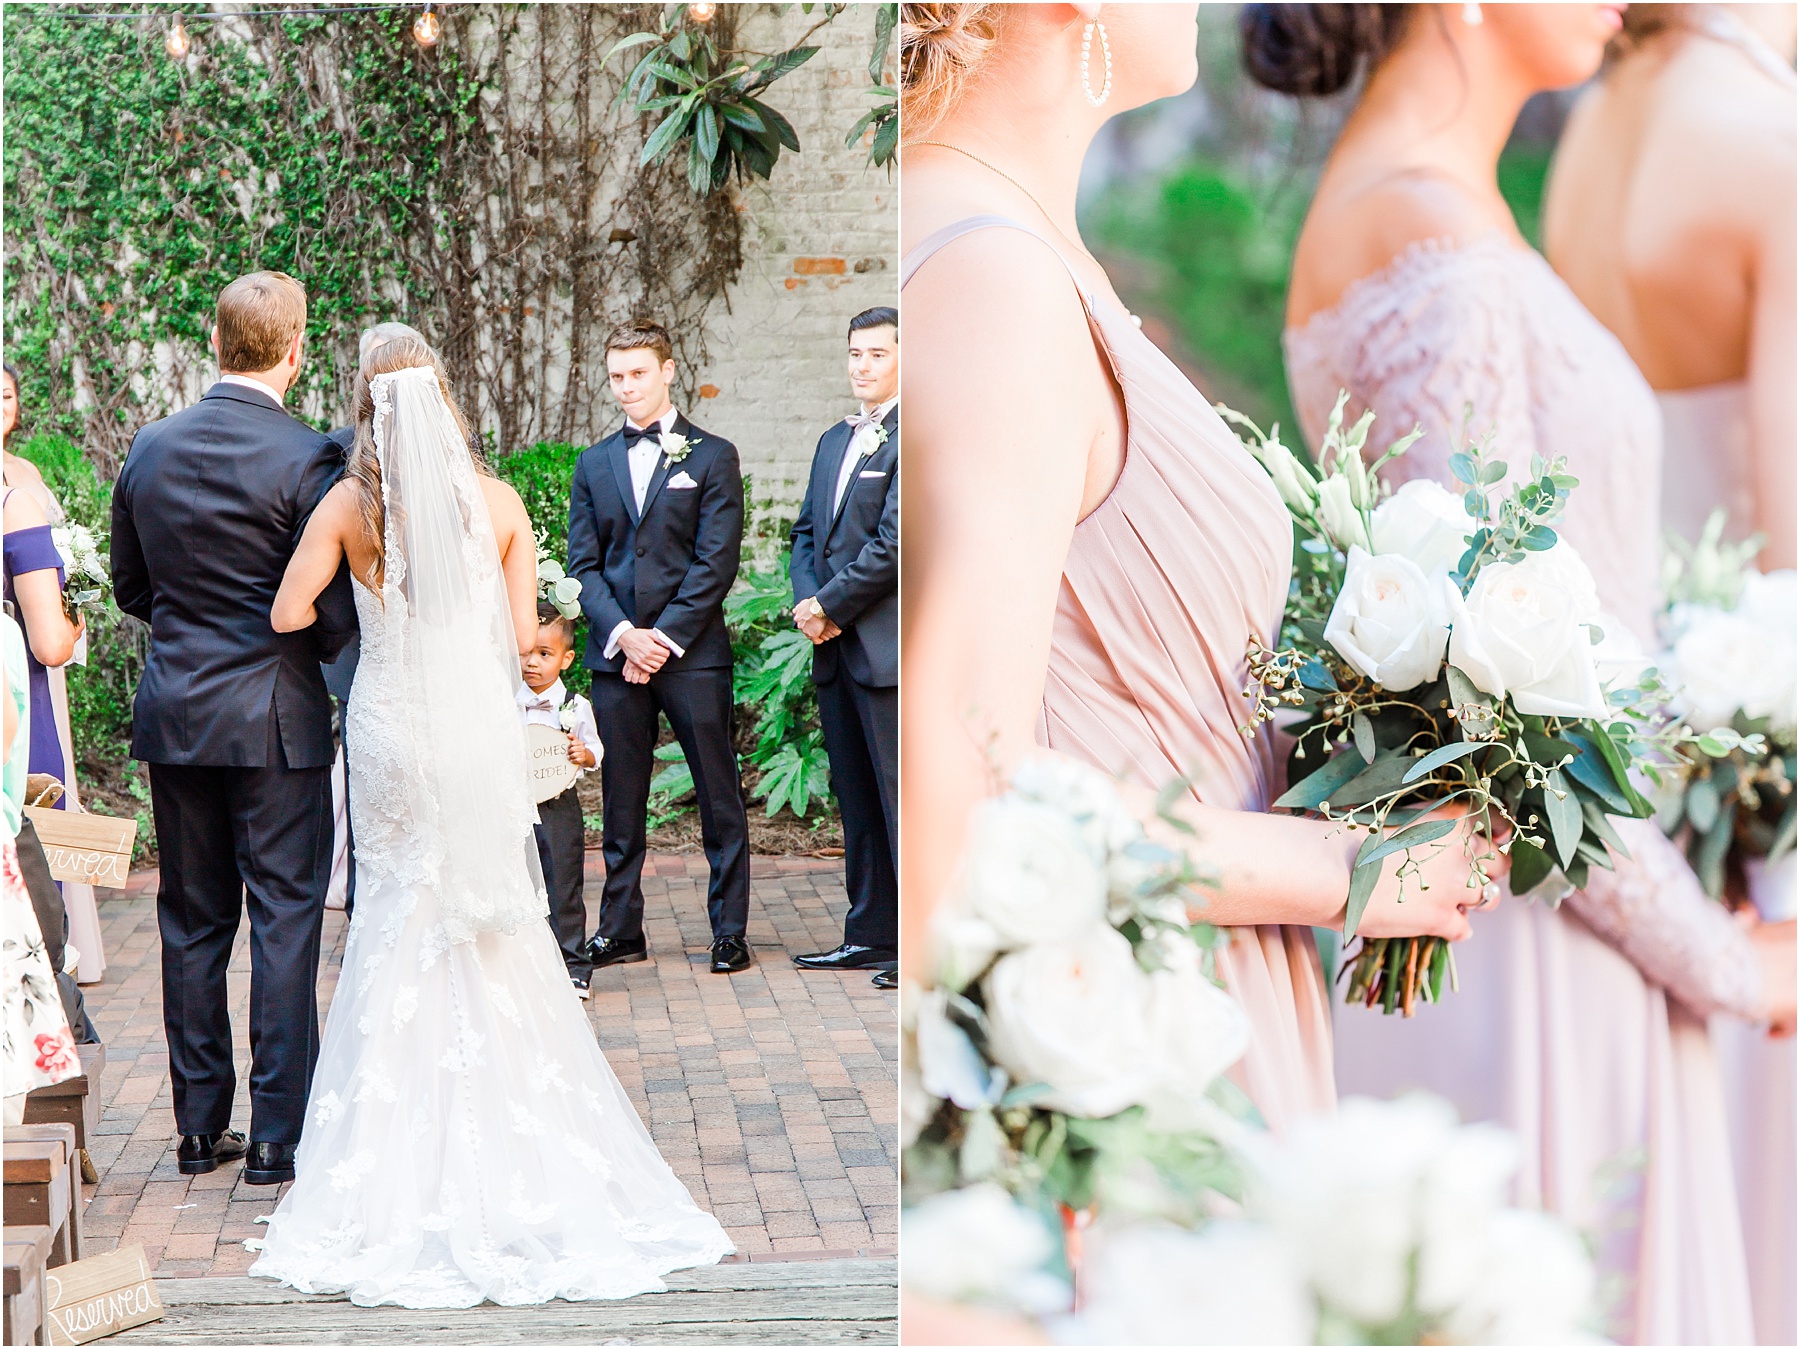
[1219, 394, 1669, 1016]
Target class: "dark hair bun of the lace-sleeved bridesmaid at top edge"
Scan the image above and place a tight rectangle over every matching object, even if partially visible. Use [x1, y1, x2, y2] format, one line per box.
[1238, 5, 1413, 99]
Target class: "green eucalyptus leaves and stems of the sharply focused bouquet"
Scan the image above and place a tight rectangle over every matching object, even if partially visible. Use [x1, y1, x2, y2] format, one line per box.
[1220, 407, 1696, 1016]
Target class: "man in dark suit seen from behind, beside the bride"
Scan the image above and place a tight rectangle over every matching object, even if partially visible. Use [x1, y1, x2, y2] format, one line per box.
[112, 272, 356, 1185]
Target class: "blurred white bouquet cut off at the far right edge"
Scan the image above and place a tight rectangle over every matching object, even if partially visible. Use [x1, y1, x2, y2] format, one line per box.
[1658, 510, 1796, 920]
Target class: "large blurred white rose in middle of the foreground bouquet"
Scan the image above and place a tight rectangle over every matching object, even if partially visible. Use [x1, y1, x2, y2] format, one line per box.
[983, 922, 1163, 1118]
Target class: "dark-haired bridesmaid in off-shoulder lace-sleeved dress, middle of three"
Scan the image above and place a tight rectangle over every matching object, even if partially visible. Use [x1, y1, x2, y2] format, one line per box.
[1244, 4, 1793, 1344]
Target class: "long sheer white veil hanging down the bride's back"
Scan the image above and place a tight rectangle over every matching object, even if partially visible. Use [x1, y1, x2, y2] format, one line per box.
[365, 366, 547, 942]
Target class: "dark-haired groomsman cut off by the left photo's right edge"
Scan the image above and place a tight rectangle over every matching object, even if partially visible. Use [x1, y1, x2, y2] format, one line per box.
[788, 306, 900, 989]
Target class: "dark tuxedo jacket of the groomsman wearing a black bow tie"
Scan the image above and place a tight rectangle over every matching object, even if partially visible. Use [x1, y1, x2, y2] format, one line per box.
[569, 405, 743, 674]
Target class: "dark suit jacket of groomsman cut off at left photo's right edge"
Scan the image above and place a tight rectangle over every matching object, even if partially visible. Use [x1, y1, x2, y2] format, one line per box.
[788, 403, 900, 688]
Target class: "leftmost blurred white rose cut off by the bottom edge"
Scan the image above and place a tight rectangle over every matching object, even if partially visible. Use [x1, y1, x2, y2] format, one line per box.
[1057, 1221, 1318, 1344]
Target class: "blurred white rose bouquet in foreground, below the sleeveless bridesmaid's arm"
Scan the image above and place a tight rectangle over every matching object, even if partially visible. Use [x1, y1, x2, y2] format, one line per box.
[902, 760, 1249, 1221]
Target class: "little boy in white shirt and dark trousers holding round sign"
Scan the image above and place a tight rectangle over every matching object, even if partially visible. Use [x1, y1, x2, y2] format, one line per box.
[518, 600, 605, 998]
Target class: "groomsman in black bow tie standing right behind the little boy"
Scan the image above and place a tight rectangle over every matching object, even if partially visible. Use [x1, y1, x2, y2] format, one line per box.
[569, 322, 751, 974]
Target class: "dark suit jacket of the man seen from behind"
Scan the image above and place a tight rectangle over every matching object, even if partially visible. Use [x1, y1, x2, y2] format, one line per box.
[112, 384, 356, 769]
